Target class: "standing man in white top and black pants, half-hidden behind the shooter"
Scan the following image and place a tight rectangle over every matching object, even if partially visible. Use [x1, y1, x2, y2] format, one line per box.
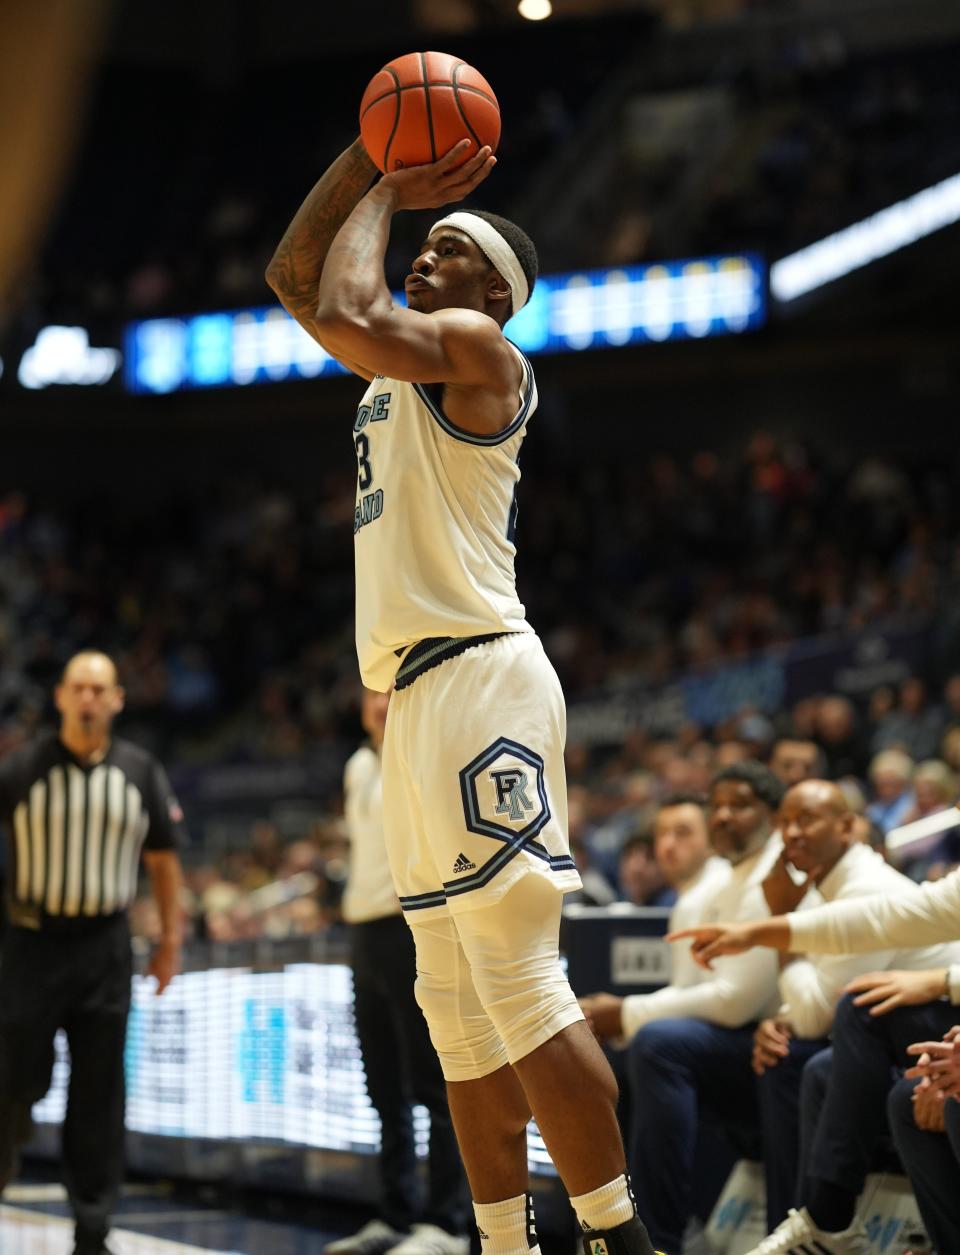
[325, 689, 469, 1255]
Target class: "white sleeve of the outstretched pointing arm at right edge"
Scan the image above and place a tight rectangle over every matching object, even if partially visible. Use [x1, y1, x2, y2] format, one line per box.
[789, 871, 960, 1004]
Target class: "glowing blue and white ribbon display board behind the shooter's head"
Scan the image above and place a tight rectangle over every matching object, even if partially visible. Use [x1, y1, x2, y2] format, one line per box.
[123, 254, 767, 393]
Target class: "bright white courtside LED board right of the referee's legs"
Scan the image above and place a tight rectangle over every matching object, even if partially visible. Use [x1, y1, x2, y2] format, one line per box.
[34, 963, 555, 1175]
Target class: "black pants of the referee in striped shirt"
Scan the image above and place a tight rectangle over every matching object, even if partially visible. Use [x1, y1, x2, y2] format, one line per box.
[0, 914, 132, 1250]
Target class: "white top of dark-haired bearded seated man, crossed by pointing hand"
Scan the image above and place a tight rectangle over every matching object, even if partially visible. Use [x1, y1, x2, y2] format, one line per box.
[622, 833, 783, 1039]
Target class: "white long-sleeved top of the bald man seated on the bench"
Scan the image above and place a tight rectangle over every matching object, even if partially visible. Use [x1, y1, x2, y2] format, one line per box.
[779, 843, 960, 1038]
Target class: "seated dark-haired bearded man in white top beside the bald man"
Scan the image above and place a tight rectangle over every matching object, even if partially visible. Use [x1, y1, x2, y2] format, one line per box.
[585, 762, 783, 1255]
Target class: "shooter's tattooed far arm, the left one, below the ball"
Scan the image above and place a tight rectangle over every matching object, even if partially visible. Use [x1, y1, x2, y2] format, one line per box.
[266, 139, 376, 379]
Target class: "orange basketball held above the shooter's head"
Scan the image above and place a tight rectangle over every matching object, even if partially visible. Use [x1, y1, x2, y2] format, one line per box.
[360, 53, 499, 173]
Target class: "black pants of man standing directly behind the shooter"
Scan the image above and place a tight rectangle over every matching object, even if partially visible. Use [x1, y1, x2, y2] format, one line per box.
[350, 915, 466, 1234]
